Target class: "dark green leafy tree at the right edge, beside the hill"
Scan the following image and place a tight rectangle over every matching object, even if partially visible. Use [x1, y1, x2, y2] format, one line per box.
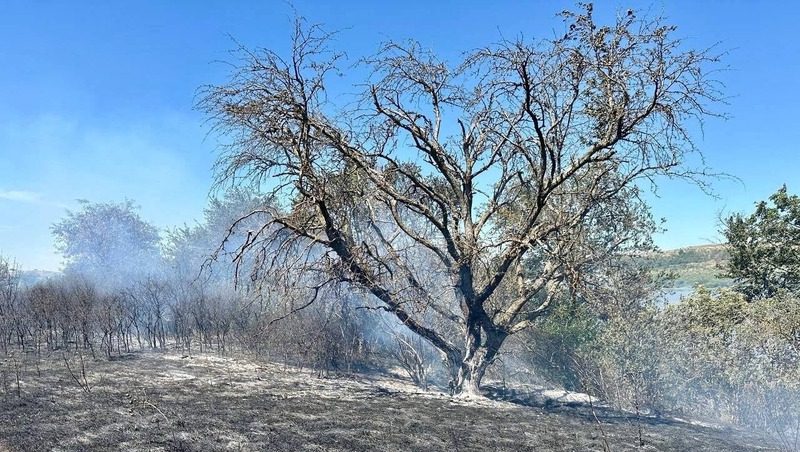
[723, 185, 800, 299]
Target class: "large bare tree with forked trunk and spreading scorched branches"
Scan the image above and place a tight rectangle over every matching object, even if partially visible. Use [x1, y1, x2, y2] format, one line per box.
[200, 5, 720, 394]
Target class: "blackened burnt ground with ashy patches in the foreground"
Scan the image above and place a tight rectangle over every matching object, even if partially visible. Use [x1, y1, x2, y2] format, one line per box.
[0, 353, 778, 451]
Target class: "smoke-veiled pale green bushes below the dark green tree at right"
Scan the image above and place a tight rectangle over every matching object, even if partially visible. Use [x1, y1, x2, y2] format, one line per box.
[576, 288, 800, 448]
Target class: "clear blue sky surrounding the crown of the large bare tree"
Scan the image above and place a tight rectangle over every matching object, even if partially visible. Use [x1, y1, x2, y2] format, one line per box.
[0, 0, 800, 270]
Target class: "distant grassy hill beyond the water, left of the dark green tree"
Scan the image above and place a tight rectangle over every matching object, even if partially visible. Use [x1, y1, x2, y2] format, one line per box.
[651, 244, 732, 288]
